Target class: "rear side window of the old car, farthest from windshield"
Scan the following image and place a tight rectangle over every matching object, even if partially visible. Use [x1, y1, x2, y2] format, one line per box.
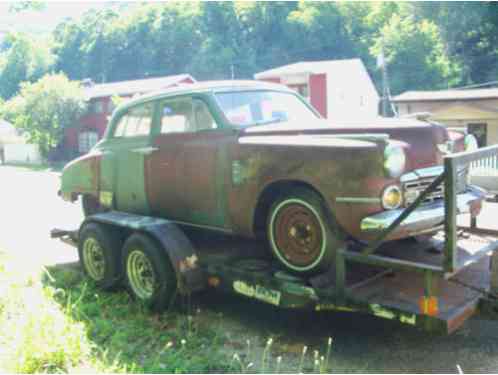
[114, 103, 153, 138]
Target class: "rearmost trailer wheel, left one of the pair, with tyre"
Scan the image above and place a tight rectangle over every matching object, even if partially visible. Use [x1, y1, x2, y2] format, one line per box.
[78, 223, 121, 289]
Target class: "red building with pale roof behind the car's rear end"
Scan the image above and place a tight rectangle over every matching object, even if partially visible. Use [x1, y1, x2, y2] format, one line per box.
[62, 74, 195, 157]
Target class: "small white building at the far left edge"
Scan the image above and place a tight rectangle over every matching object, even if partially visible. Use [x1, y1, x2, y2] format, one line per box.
[0, 119, 42, 164]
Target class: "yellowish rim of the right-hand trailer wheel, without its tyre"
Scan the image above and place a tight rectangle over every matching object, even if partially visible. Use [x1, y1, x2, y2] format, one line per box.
[126, 250, 156, 300]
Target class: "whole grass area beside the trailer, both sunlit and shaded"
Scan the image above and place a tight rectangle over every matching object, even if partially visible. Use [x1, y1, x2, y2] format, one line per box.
[0, 251, 336, 373]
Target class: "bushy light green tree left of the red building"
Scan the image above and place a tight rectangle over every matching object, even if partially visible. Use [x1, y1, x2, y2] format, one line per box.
[0, 74, 86, 156]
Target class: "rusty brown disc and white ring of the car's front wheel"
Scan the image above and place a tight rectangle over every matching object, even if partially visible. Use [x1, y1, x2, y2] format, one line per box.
[273, 203, 324, 267]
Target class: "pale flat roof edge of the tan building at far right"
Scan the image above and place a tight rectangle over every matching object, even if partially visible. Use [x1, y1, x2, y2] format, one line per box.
[393, 88, 498, 103]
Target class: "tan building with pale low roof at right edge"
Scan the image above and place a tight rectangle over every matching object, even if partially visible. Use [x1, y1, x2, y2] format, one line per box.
[393, 88, 498, 147]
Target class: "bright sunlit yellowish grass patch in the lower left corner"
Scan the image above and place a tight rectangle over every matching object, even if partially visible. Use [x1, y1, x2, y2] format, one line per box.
[0, 256, 101, 373]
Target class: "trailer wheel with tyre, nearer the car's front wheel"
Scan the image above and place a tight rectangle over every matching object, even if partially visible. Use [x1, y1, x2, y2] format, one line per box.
[123, 233, 177, 311]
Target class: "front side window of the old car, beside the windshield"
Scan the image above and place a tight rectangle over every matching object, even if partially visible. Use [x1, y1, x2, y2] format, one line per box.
[161, 98, 217, 134]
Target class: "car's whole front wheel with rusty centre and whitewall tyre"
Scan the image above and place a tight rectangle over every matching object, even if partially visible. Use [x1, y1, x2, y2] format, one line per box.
[267, 189, 339, 274]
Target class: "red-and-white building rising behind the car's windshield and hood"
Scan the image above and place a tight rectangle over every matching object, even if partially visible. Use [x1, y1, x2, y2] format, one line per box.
[254, 59, 379, 120]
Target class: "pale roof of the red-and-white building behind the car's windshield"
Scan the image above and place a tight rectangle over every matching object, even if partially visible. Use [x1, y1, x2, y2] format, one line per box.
[254, 59, 365, 79]
